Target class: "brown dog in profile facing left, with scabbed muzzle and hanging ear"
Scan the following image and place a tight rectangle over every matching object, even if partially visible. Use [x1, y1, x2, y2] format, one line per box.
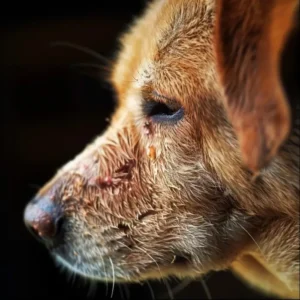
[25, 0, 299, 297]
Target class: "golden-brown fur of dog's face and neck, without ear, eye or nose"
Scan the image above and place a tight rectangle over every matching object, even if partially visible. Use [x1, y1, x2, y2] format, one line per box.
[31, 0, 299, 297]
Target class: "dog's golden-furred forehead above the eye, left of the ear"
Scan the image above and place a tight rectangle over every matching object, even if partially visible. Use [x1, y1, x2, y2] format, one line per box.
[112, 0, 215, 105]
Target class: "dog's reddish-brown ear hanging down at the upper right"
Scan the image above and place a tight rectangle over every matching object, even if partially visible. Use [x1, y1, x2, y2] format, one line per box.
[215, 0, 299, 173]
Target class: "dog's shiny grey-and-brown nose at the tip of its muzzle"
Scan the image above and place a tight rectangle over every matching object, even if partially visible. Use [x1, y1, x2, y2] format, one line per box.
[24, 196, 62, 243]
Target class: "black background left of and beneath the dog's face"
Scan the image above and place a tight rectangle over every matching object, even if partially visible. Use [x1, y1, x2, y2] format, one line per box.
[0, 0, 270, 300]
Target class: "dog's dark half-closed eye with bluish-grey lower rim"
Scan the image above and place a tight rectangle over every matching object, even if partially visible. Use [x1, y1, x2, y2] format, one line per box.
[143, 100, 184, 123]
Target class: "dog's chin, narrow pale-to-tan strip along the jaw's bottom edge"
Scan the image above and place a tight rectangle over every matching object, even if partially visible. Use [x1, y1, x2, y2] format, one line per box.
[52, 254, 198, 283]
